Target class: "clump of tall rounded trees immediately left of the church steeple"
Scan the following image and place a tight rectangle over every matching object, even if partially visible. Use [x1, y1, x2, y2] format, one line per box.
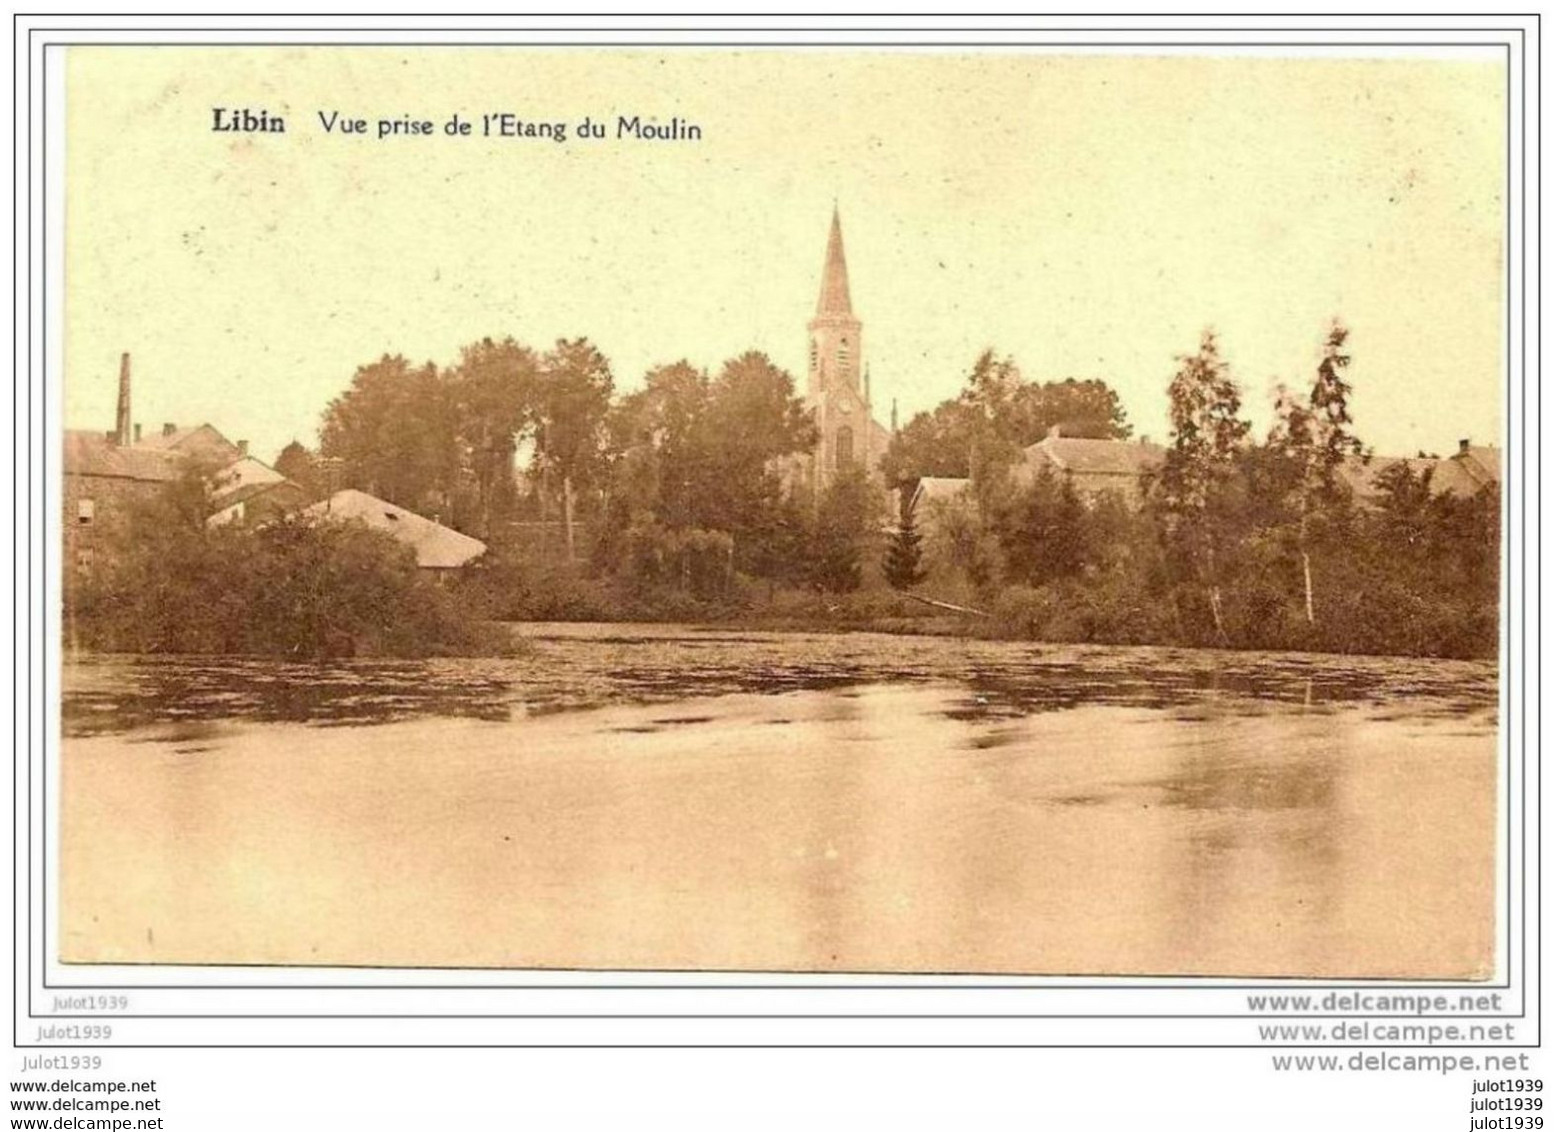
[277, 339, 886, 597]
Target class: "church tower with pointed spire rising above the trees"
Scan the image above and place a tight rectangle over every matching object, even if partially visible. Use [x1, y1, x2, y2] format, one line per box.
[803, 208, 890, 493]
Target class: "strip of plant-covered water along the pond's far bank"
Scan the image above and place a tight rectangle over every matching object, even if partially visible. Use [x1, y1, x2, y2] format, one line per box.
[64, 625, 1497, 735]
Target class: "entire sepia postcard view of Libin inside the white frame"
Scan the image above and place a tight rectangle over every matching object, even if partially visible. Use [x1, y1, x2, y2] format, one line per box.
[57, 44, 1510, 983]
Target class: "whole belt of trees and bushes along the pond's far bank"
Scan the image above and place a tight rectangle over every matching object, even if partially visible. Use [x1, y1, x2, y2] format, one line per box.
[67, 323, 1500, 656]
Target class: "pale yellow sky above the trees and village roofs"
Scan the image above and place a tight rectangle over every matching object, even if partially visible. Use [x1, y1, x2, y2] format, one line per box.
[65, 48, 1506, 459]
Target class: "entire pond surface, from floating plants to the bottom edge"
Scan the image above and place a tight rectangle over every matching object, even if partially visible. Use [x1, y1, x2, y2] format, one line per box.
[61, 627, 1495, 978]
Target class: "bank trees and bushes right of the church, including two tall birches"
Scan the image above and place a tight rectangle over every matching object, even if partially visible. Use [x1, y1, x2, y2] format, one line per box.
[890, 322, 1500, 656]
